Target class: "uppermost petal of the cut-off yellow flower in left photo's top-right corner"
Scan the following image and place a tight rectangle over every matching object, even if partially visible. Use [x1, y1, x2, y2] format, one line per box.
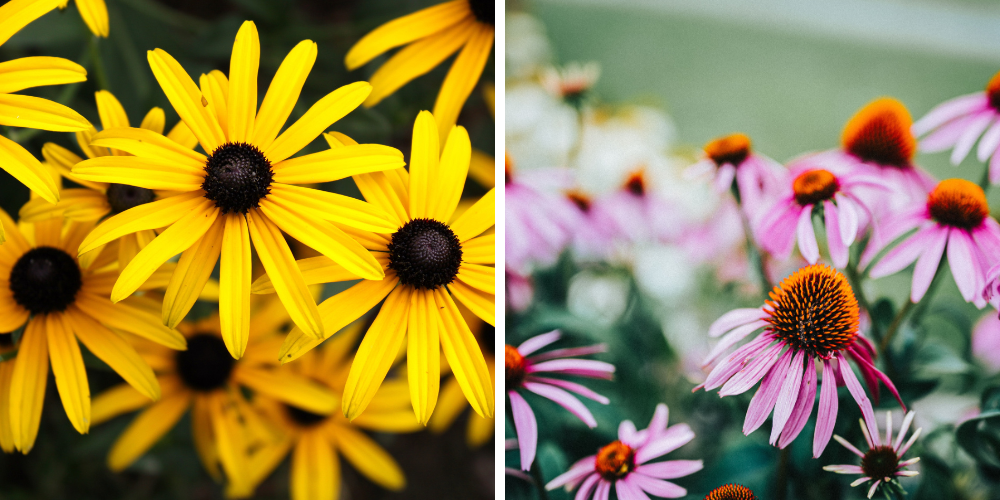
[344, 0, 472, 70]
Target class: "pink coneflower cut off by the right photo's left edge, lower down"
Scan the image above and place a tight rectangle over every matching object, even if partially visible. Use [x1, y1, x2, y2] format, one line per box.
[504, 330, 615, 470]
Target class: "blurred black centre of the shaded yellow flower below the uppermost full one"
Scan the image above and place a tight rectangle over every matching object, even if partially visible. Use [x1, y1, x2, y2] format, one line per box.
[175, 333, 236, 392]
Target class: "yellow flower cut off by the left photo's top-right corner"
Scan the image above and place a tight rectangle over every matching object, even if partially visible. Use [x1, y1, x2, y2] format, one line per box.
[344, 0, 496, 143]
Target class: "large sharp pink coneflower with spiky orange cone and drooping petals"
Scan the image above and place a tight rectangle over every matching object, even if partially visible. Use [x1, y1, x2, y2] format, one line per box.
[696, 264, 903, 457]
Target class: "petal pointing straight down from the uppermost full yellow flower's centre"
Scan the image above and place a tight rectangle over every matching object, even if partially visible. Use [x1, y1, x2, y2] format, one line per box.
[219, 214, 251, 359]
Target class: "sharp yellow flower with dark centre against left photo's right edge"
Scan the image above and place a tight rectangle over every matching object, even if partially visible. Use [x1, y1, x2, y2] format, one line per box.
[253, 111, 496, 423]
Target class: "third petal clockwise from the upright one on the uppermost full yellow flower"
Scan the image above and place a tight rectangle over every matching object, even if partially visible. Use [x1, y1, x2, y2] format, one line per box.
[264, 82, 372, 165]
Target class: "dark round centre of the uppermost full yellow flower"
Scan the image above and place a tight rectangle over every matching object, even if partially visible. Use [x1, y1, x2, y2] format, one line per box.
[201, 142, 274, 214]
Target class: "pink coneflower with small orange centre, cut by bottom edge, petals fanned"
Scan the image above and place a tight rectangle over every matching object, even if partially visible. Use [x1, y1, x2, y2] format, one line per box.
[545, 403, 703, 500]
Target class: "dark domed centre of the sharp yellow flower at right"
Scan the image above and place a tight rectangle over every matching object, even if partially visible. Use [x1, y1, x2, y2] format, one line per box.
[389, 219, 462, 289]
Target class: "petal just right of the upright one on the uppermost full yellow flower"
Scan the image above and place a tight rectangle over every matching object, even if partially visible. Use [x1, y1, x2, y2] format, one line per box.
[252, 40, 316, 150]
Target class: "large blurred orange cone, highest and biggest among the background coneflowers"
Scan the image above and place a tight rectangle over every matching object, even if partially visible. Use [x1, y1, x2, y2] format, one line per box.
[841, 97, 917, 168]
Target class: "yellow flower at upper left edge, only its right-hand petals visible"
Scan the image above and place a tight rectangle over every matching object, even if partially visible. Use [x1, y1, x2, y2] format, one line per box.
[0, 0, 90, 243]
